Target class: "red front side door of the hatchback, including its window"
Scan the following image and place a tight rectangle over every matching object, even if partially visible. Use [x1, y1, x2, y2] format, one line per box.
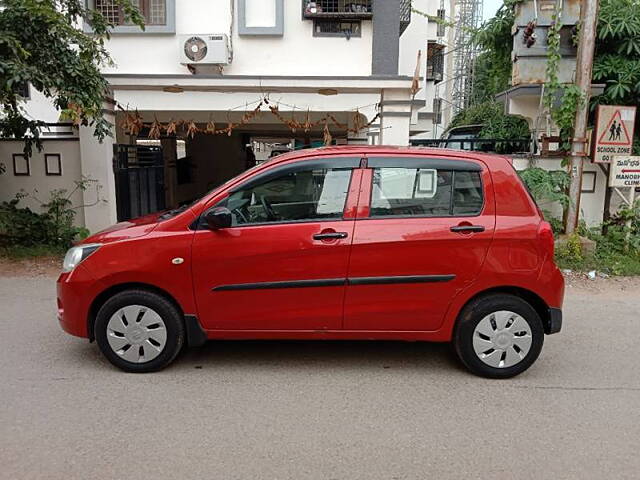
[192, 158, 360, 330]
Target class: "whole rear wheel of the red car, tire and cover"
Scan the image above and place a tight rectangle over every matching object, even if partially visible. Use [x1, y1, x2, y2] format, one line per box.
[453, 294, 544, 378]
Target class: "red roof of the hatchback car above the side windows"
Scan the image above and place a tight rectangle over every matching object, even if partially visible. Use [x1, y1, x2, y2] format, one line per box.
[265, 145, 510, 165]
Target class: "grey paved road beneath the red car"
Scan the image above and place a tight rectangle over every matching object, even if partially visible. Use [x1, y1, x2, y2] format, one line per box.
[0, 277, 640, 480]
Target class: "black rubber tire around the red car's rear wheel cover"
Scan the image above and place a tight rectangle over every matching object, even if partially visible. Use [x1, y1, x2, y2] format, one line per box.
[453, 294, 544, 378]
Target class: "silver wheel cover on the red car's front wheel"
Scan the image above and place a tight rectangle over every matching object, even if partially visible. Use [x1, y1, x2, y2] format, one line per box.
[107, 305, 167, 363]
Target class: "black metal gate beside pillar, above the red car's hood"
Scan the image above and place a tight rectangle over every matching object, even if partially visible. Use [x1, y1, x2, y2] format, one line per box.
[113, 144, 165, 222]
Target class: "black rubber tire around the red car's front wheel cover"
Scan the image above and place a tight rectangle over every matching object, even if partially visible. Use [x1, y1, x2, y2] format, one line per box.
[94, 290, 185, 373]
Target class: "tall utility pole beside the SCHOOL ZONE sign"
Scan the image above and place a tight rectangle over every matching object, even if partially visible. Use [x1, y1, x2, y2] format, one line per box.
[565, 0, 598, 234]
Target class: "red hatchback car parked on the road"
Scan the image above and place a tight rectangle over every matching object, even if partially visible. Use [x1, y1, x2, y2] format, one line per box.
[57, 146, 564, 378]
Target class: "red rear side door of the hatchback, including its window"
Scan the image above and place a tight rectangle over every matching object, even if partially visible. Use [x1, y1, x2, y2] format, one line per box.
[344, 156, 495, 331]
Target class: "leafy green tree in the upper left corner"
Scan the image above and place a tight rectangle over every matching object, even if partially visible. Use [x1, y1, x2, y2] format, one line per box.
[0, 0, 144, 155]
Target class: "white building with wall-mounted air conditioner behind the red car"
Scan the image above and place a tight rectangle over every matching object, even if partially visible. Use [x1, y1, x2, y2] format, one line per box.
[0, 0, 458, 231]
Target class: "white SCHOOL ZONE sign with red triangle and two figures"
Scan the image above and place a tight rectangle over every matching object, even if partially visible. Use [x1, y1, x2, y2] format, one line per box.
[591, 105, 636, 163]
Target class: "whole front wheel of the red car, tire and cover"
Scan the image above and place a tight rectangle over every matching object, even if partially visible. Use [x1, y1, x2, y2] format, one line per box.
[95, 290, 185, 373]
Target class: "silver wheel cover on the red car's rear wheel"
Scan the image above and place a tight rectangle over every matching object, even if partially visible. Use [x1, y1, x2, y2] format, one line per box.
[473, 310, 533, 368]
